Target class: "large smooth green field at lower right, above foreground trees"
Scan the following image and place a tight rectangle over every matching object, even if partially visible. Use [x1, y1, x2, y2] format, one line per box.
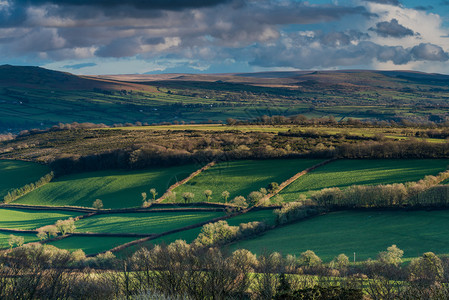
[231, 211, 449, 261]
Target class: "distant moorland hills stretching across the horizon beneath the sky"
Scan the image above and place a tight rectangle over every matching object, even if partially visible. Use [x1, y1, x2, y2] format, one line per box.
[0, 65, 449, 132]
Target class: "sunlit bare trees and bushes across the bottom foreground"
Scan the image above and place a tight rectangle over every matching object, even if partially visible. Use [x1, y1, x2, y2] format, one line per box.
[0, 240, 449, 300]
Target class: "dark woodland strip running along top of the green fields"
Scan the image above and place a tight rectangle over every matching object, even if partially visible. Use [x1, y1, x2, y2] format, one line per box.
[45, 139, 449, 176]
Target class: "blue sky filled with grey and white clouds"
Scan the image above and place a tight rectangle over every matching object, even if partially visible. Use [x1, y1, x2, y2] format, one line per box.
[0, 0, 449, 75]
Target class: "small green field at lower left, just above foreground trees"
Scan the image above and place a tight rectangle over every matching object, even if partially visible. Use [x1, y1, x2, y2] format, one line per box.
[48, 236, 138, 255]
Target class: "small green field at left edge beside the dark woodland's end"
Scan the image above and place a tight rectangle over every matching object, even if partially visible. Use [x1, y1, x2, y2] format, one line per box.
[0, 160, 50, 199]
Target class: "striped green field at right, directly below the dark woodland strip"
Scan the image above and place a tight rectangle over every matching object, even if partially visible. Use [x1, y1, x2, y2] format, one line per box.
[280, 159, 449, 201]
